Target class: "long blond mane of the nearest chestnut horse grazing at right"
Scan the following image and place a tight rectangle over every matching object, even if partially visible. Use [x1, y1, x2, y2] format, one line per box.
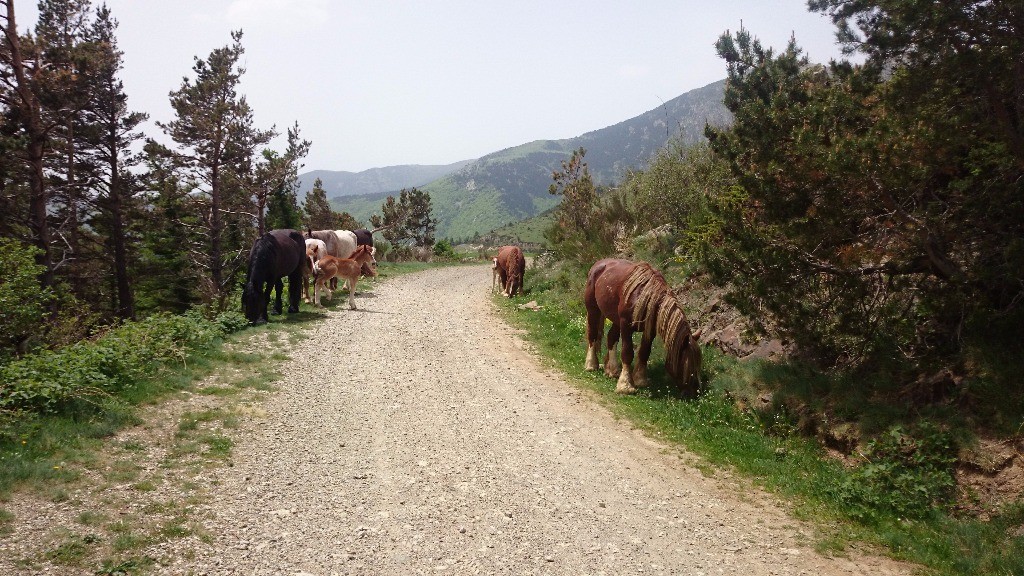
[623, 262, 699, 382]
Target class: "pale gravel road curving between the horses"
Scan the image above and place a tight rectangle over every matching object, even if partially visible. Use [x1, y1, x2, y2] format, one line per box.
[176, 266, 908, 575]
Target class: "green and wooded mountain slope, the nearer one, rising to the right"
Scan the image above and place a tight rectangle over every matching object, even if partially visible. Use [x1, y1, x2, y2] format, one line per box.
[329, 80, 731, 240]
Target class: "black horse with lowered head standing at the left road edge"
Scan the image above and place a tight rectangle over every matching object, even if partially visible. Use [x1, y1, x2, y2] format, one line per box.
[242, 230, 306, 324]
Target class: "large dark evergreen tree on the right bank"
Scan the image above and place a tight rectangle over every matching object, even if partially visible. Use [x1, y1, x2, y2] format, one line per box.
[708, 7, 1024, 363]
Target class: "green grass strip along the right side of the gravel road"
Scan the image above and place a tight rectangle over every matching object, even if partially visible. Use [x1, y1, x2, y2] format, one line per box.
[494, 262, 1024, 576]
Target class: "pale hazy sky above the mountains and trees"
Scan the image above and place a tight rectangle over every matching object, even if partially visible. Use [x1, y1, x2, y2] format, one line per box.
[15, 0, 839, 171]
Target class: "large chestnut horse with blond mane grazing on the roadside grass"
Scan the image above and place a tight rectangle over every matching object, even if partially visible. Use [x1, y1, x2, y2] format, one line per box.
[584, 258, 701, 396]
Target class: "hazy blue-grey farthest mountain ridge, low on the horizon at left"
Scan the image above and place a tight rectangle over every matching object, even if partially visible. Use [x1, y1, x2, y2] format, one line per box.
[299, 160, 472, 198]
